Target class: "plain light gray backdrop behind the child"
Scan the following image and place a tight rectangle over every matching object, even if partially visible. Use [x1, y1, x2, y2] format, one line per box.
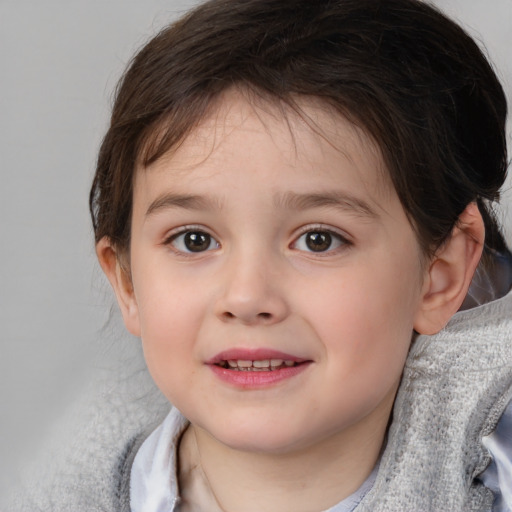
[0, 0, 512, 494]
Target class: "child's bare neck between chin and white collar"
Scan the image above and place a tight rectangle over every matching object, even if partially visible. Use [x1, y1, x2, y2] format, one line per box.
[180, 404, 389, 512]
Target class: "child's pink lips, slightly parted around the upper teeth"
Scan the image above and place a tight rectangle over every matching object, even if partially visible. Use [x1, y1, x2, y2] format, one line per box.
[206, 348, 312, 390]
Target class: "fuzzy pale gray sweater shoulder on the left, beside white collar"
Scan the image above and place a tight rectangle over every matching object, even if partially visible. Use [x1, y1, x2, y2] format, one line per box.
[6, 352, 170, 512]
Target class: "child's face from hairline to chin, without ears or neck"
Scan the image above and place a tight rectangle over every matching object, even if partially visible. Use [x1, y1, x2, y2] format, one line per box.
[127, 93, 428, 453]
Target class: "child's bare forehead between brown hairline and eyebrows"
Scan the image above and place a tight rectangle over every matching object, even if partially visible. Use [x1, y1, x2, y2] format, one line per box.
[134, 90, 394, 207]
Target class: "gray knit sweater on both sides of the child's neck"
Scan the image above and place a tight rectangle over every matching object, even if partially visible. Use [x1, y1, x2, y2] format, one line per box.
[2, 293, 512, 512]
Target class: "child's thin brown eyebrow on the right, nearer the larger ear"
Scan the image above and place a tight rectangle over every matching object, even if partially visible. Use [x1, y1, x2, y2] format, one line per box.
[274, 191, 379, 219]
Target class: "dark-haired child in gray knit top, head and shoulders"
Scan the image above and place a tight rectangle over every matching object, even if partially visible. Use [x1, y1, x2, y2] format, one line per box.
[10, 0, 512, 512]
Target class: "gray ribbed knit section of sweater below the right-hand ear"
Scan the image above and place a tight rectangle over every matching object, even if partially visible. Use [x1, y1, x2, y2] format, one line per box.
[356, 293, 512, 512]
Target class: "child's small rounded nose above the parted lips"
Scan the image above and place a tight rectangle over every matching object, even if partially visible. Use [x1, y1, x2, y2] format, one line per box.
[216, 255, 289, 325]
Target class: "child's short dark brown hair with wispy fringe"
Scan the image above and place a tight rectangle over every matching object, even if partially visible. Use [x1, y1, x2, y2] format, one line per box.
[90, 0, 507, 254]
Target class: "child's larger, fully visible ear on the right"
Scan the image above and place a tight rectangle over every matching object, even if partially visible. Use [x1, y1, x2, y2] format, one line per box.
[414, 203, 485, 334]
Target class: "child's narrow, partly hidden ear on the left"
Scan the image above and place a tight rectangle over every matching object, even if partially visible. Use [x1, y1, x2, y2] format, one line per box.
[96, 237, 140, 336]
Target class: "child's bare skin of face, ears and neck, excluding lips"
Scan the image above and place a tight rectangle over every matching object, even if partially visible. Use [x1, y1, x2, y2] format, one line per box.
[98, 91, 483, 512]
